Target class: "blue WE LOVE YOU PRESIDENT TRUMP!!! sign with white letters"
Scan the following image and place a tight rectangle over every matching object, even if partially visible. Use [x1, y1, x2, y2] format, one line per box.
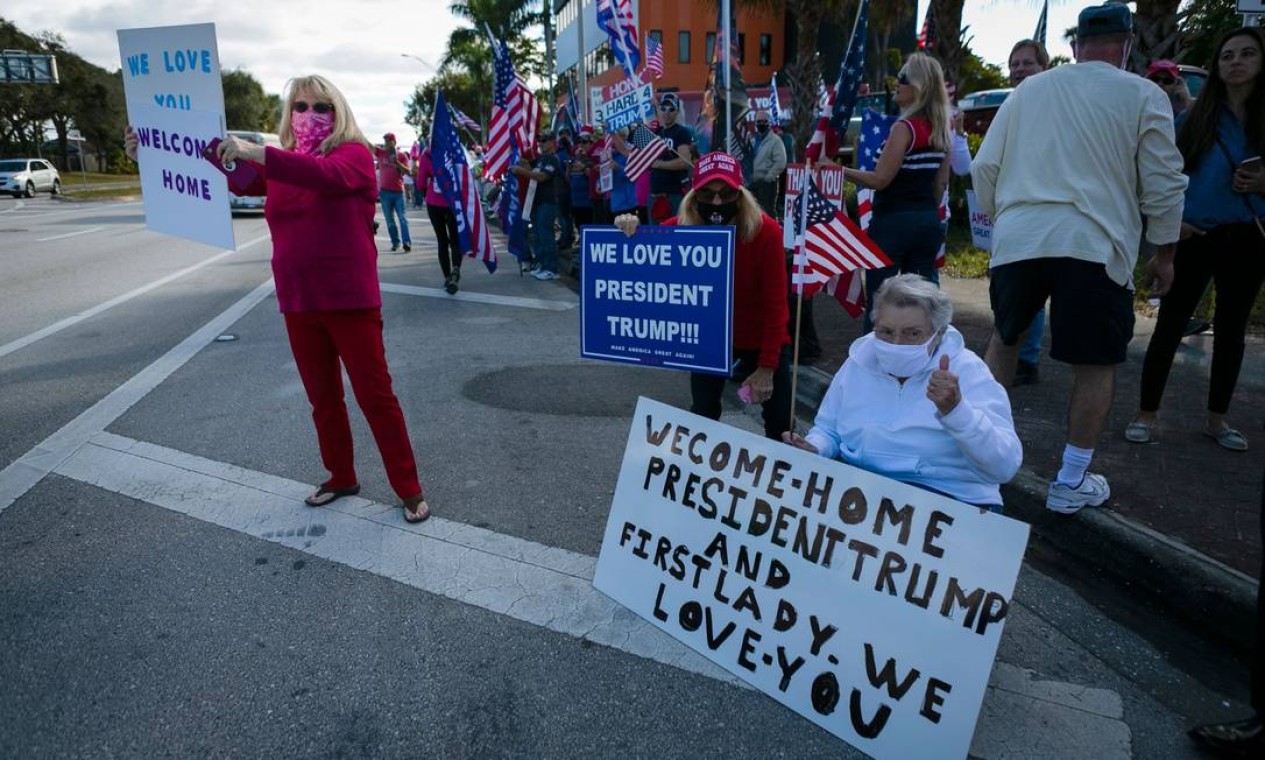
[579, 226, 734, 376]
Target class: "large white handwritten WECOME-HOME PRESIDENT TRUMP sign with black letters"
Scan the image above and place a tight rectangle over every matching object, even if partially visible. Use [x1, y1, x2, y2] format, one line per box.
[593, 398, 1028, 760]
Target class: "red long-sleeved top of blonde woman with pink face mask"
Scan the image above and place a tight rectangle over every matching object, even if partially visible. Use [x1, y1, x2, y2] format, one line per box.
[234, 143, 382, 312]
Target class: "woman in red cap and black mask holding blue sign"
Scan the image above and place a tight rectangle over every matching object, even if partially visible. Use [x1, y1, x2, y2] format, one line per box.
[615, 152, 791, 440]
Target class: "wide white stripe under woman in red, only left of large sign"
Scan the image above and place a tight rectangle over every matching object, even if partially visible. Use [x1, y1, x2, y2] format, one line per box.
[54, 434, 745, 685]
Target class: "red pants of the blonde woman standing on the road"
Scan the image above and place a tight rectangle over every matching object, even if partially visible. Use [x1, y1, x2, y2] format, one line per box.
[285, 309, 421, 498]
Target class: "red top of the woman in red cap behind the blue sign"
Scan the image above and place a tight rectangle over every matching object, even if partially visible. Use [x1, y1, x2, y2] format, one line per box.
[664, 214, 791, 369]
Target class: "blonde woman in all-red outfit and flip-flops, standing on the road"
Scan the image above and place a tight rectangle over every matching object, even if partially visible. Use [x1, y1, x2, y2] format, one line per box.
[127, 76, 430, 522]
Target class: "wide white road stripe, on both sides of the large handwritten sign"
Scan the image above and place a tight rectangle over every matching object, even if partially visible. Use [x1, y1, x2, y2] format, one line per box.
[46, 432, 1132, 760]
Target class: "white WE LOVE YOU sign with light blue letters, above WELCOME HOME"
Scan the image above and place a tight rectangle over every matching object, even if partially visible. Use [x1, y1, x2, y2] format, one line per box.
[119, 24, 224, 116]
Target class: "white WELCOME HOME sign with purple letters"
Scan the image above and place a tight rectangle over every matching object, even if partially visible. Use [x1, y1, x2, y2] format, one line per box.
[129, 105, 237, 248]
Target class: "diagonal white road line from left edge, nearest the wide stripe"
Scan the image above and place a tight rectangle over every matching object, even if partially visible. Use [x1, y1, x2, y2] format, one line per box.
[0, 279, 273, 512]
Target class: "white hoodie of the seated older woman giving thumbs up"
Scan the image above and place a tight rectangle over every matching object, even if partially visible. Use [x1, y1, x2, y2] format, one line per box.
[807, 326, 1023, 505]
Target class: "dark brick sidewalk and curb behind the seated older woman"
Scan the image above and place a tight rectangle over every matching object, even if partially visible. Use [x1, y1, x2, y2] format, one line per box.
[798, 277, 1265, 646]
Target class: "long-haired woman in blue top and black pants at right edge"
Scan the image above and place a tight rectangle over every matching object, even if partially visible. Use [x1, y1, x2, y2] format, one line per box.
[1125, 28, 1265, 451]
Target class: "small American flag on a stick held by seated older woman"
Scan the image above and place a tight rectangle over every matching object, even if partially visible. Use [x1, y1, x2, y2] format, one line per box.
[792, 173, 892, 297]
